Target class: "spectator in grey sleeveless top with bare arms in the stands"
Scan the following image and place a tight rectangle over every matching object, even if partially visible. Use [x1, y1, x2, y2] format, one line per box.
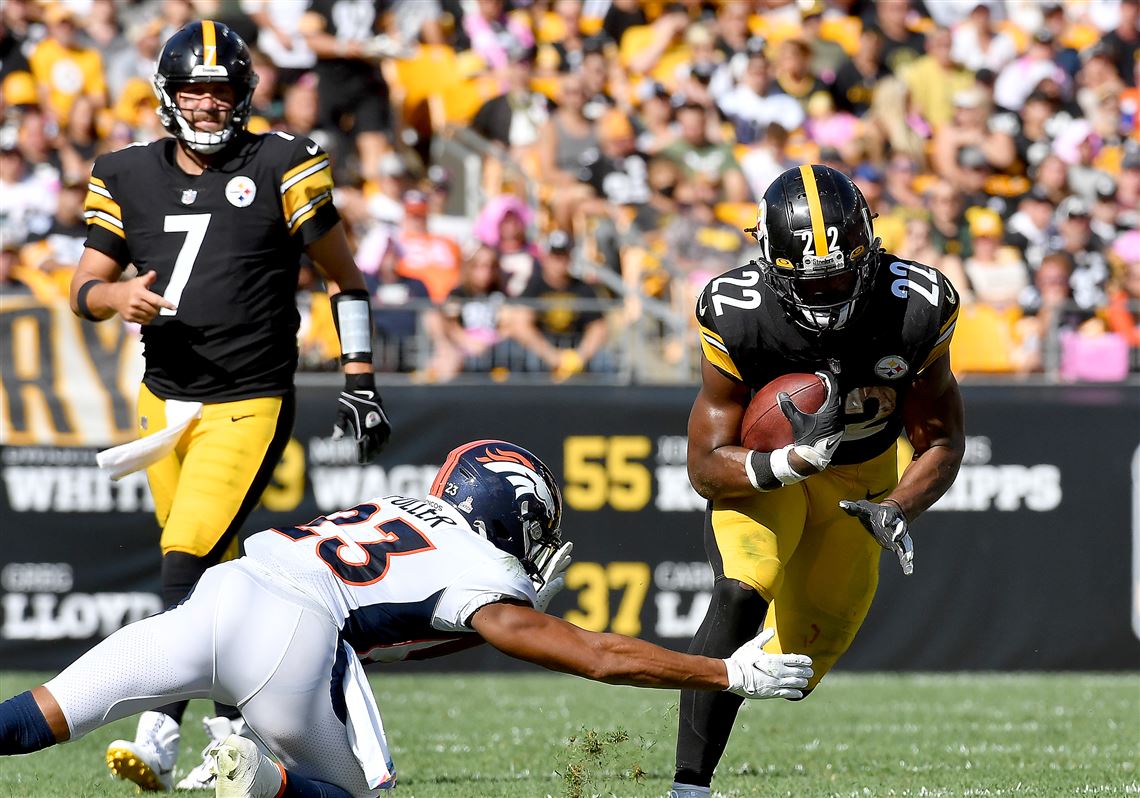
[538, 73, 601, 229]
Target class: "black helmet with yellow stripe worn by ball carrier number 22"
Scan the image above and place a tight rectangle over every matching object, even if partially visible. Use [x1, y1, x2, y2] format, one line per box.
[744, 164, 882, 333]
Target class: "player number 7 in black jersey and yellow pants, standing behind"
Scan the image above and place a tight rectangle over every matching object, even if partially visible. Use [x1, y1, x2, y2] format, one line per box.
[71, 21, 390, 789]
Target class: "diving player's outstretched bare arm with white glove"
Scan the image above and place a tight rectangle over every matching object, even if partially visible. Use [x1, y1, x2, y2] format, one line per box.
[471, 602, 812, 698]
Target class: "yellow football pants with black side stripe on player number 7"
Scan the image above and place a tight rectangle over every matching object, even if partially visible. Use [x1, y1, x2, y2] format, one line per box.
[138, 385, 294, 561]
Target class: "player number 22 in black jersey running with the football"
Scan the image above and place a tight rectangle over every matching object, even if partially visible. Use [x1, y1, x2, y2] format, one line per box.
[670, 165, 964, 798]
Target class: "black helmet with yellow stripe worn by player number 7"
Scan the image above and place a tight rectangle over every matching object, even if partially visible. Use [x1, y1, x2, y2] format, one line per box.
[153, 19, 258, 155]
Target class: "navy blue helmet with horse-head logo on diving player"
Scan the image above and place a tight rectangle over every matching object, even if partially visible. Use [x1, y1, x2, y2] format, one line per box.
[430, 440, 562, 577]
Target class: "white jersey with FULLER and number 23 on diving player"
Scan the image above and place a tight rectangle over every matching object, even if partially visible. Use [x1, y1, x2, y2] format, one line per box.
[245, 496, 535, 661]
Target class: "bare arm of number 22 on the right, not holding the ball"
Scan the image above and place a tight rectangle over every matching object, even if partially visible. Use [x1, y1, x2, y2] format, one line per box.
[889, 353, 966, 522]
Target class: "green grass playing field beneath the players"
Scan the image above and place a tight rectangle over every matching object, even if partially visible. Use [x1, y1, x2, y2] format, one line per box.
[0, 673, 1140, 798]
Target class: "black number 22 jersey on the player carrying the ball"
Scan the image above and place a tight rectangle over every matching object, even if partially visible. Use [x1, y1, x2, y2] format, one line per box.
[697, 257, 958, 465]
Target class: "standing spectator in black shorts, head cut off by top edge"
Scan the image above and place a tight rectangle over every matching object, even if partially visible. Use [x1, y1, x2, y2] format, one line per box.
[299, 0, 392, 180]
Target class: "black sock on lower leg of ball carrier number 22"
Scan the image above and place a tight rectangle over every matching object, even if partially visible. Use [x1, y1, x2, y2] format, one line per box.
[674, 577, 768, 787]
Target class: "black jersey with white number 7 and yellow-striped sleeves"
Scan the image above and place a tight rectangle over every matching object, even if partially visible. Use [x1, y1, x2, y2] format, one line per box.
[86, 133, 340, 401]
